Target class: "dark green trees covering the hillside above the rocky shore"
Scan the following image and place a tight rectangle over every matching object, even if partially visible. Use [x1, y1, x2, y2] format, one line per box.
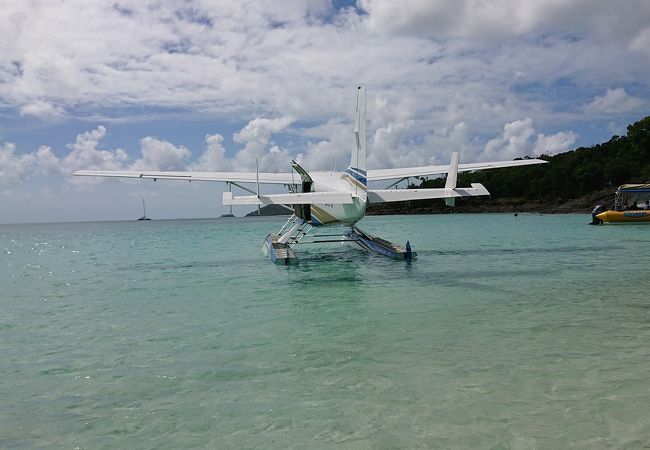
[420, 116, 650, 202]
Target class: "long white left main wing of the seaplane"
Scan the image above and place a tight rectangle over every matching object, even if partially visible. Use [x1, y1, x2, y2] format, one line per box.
[72, 170, 300, 184]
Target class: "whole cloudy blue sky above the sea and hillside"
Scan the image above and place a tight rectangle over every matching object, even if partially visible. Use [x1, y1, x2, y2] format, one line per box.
[0, 0, 650, 223]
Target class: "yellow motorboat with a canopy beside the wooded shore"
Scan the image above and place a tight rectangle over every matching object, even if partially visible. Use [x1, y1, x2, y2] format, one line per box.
[591, 183, 650, 225]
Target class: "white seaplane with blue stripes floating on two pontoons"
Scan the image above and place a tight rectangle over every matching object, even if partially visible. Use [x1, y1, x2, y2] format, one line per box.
[73, 85, 547, 265]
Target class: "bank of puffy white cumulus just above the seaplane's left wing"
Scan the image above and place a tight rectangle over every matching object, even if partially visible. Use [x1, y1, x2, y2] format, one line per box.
[0, 118, 298, 186]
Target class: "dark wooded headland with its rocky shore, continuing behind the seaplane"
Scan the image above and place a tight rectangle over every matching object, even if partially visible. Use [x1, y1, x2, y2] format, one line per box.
[248, 116, 650, 216]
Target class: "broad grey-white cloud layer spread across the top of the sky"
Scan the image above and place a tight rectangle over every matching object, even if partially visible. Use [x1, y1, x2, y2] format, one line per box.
[0, 0, 650, 139]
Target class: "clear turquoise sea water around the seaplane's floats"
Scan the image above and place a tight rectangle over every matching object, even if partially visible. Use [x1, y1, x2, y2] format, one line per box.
[0, 214, 650, 449]
